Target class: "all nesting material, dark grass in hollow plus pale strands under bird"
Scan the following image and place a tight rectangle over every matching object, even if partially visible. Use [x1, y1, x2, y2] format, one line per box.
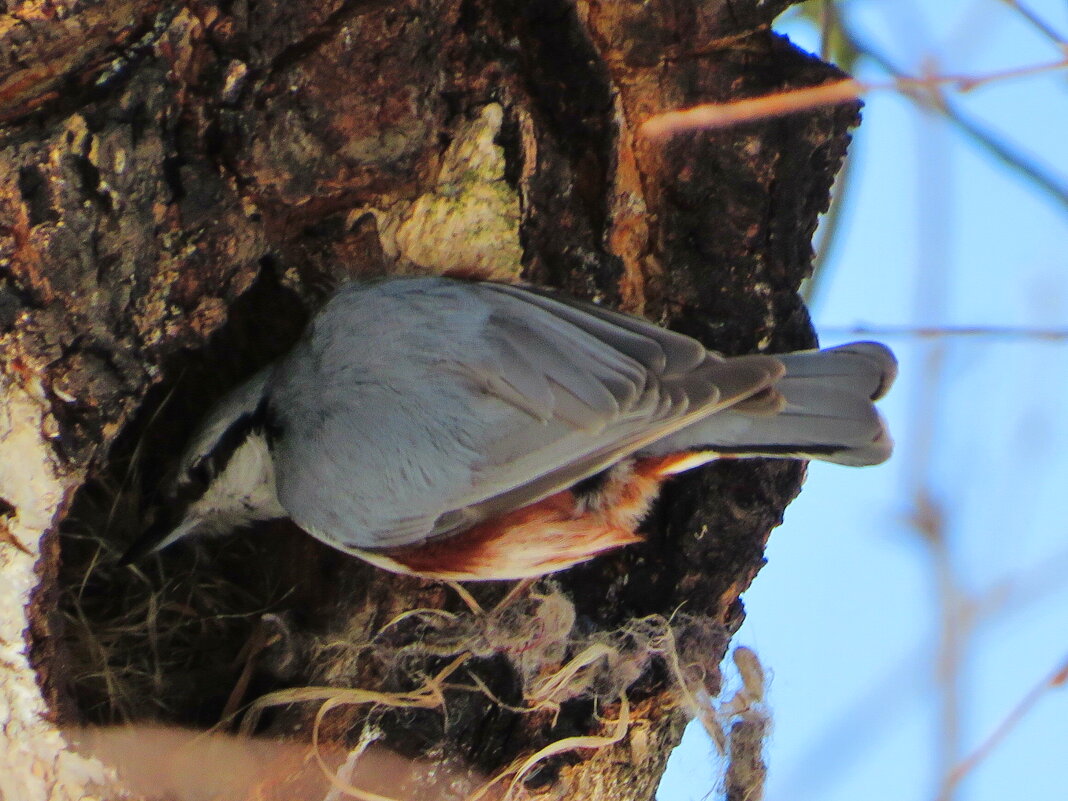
[59, 463, 734, 796]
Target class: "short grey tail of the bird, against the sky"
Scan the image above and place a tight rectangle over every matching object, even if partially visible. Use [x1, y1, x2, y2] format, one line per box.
[642, 342, 897, 469]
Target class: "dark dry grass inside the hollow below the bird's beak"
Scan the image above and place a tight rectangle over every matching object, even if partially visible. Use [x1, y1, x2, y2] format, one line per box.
[57, 457, 301, 725]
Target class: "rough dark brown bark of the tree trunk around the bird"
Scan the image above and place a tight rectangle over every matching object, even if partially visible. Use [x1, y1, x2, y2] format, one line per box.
[0, 0, 857, 801]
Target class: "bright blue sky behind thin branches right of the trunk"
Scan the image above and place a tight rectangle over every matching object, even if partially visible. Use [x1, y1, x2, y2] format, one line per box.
[658, 0, 1068, 801]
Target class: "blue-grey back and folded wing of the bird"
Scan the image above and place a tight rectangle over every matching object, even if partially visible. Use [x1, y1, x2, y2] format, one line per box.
[260, 279, 782, 548]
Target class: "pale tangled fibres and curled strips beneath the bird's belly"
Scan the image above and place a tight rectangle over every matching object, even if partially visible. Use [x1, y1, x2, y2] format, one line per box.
[273, 580, 724, 801]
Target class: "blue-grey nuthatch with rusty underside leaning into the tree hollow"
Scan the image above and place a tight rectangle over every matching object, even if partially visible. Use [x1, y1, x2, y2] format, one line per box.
[122, 276, 897, 581]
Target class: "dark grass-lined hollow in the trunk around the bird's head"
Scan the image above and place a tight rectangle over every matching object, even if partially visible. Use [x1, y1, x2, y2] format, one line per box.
[43, 269, 348, 728]
